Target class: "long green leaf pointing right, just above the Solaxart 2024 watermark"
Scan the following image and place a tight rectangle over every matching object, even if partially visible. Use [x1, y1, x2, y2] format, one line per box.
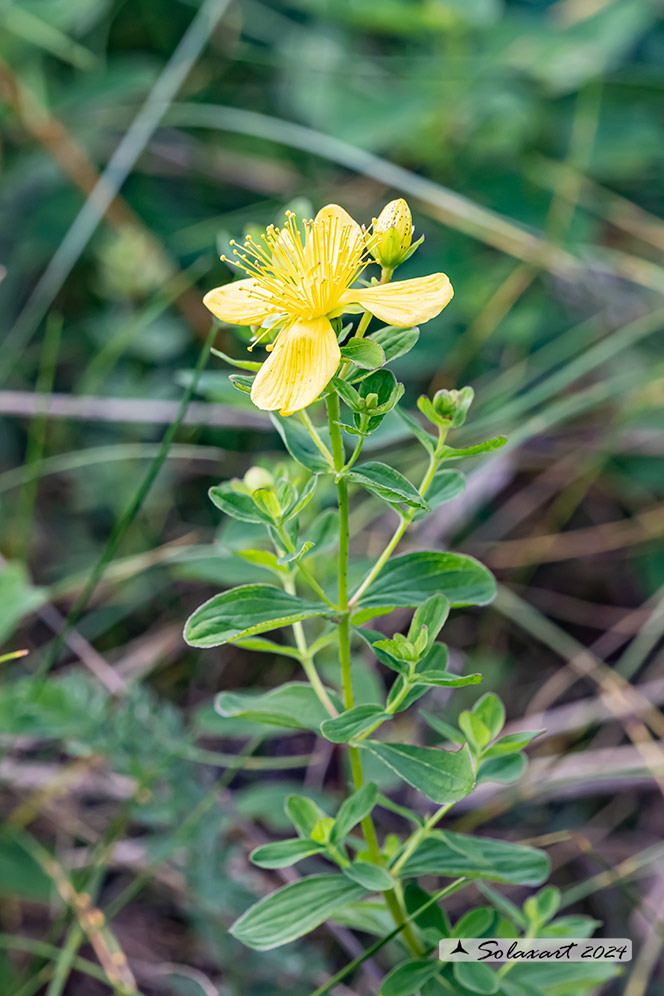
[401, 831, 549, 885]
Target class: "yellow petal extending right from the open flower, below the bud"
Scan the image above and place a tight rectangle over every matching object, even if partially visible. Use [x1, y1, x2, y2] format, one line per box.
[342, 273, 454, 328]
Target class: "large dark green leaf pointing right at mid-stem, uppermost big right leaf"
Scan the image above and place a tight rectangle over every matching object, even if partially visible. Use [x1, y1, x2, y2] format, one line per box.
[353, 552, 496, 623]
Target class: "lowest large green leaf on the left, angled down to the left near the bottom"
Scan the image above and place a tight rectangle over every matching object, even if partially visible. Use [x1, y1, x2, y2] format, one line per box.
[230, 875, 367, 951]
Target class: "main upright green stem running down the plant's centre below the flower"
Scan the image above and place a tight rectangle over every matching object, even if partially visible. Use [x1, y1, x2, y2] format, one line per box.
[327, 394, 421, 954]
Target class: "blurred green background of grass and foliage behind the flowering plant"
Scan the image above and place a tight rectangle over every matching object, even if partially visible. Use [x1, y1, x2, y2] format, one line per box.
[0, 0, 664, 996]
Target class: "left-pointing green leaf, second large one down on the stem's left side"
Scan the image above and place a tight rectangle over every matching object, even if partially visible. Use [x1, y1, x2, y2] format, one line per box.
[214, 681, 342, 732]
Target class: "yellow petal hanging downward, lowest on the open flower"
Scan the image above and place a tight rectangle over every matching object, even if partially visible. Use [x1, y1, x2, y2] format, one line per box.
[251, 318, 341, 415]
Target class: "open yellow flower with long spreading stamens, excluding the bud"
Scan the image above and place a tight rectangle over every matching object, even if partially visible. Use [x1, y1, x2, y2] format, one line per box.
[203, 204, 453, 415]
